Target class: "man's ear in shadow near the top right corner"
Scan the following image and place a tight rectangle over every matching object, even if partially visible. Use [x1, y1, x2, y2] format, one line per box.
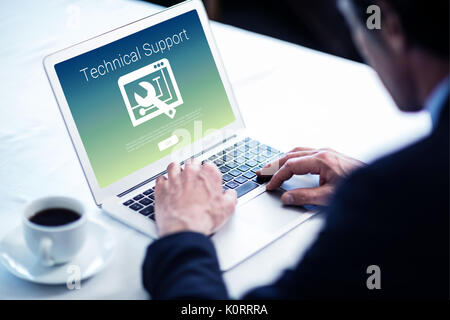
[379, 0, 408, 56]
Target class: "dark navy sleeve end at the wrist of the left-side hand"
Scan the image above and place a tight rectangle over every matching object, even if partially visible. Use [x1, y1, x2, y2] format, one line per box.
[143, 232, 228, 299]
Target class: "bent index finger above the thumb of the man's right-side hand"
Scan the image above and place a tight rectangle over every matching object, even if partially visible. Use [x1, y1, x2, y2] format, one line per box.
[266, 156, 320, 190]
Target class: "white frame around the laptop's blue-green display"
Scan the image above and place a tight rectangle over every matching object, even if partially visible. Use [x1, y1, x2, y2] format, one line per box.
[44, 0, 245, 205]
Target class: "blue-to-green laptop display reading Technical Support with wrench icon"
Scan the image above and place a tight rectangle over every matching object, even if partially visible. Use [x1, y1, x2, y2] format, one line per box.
[55, 10, 235, 188]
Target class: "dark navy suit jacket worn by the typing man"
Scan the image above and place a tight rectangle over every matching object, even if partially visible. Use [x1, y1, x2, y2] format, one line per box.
[143, 101, 449, 299]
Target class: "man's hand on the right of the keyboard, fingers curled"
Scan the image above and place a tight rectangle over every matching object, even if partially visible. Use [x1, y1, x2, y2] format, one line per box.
[256, 148, 364, 205]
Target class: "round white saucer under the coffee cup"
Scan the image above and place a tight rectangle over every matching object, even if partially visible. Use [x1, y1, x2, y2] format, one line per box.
[0, 221, 114, 284]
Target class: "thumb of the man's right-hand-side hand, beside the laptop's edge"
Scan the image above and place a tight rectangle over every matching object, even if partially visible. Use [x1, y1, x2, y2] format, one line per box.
[281, 185, 333, 206]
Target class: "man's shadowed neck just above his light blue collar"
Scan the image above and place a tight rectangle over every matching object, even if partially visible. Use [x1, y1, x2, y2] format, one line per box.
[411, 50, 449, 106]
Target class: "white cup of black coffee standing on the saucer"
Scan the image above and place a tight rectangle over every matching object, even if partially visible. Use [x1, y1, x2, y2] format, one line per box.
[23, 196, 87, 266]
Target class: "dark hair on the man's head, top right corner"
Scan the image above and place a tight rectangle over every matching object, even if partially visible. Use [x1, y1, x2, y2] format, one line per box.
[350, 0, 449, 59]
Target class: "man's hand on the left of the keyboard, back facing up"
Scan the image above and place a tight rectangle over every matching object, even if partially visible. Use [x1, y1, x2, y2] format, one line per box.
[155, 160, 237, 236]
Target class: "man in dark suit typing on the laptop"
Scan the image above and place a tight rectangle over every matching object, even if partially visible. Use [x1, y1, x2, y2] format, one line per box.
[143, 0, 449, 299]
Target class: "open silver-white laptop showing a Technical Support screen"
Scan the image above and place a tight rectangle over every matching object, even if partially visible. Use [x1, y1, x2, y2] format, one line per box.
[44, 0, 314, 271]
